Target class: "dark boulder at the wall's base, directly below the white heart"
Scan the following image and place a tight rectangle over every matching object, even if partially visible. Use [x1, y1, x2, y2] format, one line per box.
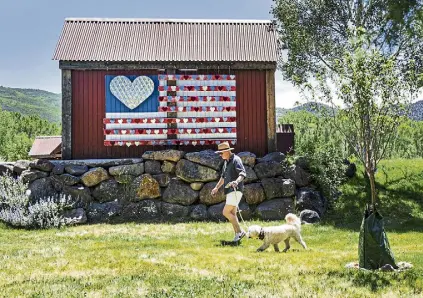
[121, 200, 162, 222]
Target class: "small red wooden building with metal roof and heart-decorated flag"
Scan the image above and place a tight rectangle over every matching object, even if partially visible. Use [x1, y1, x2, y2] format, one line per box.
[53, 18, 278, 159]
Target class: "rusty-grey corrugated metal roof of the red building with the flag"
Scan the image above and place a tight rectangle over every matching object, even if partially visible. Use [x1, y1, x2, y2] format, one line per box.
[53, 18, 278, 62]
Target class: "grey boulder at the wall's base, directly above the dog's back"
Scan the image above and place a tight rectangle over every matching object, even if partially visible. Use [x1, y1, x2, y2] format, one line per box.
[255, 198, 294, 220]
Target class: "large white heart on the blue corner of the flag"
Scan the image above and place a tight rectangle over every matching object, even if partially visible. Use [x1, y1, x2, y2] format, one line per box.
[110, 76, 154, 110]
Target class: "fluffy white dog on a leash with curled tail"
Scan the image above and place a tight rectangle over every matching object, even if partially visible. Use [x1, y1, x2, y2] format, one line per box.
[247, 213, 307, 252]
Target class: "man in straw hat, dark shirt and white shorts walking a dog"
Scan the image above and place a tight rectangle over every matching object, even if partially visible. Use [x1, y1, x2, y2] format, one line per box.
[211, 142, 247, 241]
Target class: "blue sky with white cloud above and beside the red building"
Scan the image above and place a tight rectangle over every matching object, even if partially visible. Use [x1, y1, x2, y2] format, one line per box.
[0, 0, 299, 107]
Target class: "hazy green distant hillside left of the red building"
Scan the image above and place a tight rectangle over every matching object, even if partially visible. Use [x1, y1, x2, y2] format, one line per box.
[0, 86, 62, 122]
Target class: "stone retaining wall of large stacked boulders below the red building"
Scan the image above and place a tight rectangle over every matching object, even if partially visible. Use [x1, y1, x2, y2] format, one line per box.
[0, 150, 327, 223]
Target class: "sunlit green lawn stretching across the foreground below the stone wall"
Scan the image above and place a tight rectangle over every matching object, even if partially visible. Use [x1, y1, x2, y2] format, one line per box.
[0, 160, 423, 297]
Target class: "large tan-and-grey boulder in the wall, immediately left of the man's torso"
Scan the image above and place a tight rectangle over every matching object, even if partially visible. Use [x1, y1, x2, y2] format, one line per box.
[176, 159, 220, 183]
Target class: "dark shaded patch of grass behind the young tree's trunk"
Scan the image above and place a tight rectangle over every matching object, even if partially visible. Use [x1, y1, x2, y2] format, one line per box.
[322, 172, 423, 233]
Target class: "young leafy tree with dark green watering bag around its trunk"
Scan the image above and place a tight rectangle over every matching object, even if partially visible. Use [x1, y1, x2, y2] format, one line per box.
[273, 0, 423, 269]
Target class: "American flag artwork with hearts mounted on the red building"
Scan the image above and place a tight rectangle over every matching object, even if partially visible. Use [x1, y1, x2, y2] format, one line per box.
[103, 75, 237, 147]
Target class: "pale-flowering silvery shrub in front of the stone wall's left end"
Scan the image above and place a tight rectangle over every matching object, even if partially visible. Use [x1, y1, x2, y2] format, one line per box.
[0, 175, 67, 229]
